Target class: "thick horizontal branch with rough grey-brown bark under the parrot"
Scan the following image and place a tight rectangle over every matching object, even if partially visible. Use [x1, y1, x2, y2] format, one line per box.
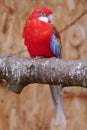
[0, 56, 87, 93]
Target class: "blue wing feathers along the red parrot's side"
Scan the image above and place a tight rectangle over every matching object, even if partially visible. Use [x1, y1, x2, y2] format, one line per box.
[50, 34, 62, 59]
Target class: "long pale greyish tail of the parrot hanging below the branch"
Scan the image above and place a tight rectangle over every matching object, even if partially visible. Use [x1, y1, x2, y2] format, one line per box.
[50, 84, 66, 130]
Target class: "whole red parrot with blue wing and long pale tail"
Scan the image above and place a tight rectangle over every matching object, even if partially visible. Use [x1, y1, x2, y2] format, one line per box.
[23, 7, 66, 128]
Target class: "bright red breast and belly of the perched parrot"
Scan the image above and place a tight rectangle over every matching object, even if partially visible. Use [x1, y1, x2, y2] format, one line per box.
[23, 20, 54, 57]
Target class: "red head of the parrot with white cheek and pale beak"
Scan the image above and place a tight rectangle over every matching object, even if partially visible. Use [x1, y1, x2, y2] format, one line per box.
[29, 7, 53, 23]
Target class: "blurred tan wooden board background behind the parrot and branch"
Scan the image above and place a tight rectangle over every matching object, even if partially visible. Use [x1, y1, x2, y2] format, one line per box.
[0, 0, 87, 130]
